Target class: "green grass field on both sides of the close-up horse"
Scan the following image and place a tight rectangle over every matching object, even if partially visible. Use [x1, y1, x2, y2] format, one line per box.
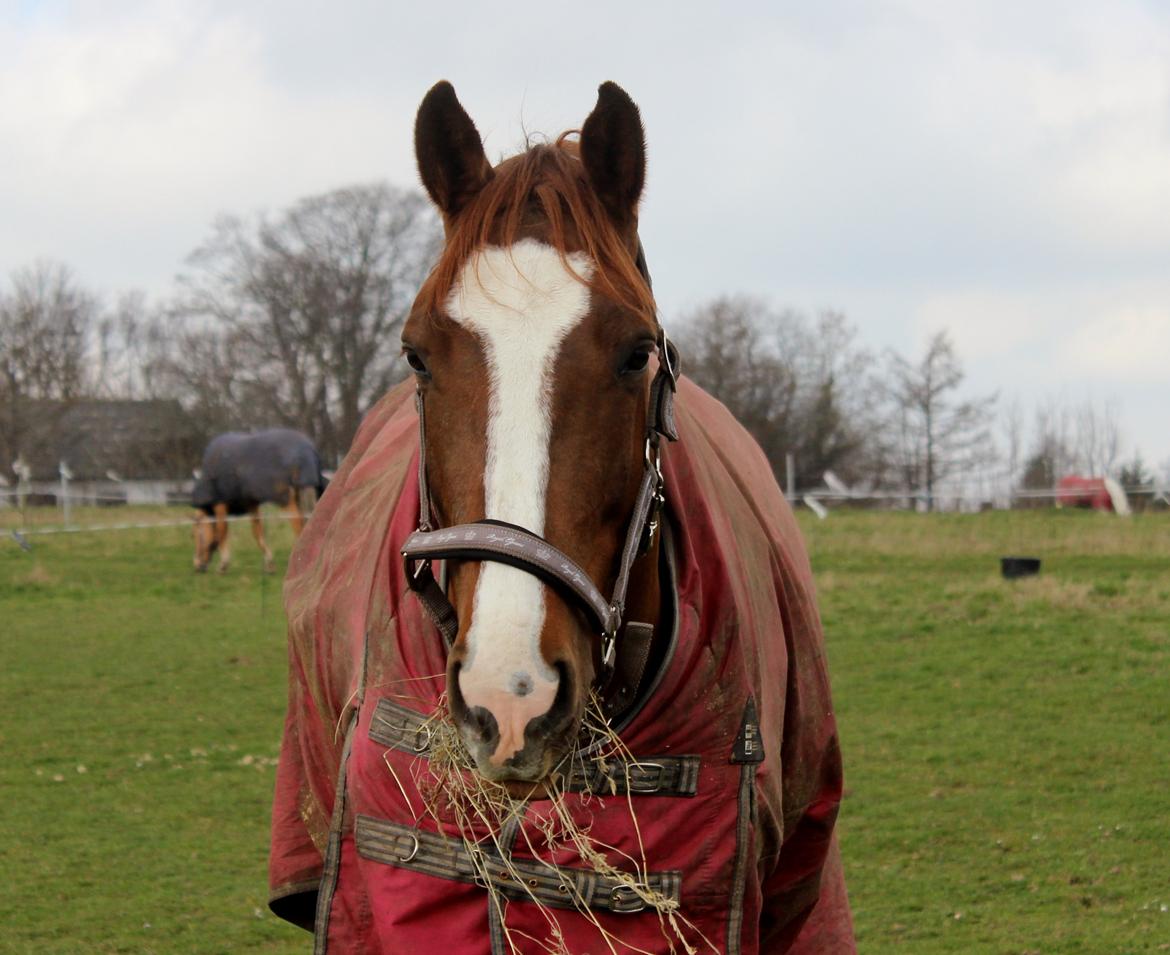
[0, 509, 1170, 955]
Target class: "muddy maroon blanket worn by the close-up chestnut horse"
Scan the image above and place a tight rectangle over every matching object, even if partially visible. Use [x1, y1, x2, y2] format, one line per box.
[270, 380, 855, 955]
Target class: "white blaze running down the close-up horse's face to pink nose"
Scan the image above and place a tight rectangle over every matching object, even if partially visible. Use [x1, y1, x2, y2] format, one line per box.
[447, 239, 592, 765]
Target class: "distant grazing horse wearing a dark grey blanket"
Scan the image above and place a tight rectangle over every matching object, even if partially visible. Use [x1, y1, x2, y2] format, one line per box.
[191, 428, 324, 573]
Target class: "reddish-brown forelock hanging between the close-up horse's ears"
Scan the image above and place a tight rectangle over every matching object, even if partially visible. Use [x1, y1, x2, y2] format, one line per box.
[417, 131, 656, 320]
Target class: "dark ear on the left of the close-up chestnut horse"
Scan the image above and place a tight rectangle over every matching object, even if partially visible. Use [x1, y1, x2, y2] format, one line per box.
[414, 80, 491, 219]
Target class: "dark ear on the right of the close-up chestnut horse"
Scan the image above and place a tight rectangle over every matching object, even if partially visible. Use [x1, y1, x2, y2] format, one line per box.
[580, 83, 646, 226]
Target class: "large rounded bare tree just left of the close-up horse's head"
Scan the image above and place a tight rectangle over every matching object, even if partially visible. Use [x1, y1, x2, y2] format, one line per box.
[180, 185, 440, 460]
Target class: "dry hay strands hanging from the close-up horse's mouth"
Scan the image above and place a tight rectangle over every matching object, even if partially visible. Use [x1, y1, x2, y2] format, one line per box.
[384, 694, 718, 955]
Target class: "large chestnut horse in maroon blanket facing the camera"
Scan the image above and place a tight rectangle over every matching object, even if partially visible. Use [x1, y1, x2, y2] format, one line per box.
[269, 82, 855, 955]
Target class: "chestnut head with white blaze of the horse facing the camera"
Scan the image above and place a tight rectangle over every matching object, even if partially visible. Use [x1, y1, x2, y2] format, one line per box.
[402, 82, 673, 781]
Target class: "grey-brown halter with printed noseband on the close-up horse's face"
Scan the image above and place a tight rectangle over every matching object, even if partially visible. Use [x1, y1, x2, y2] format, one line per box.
[401, 242, 679, 703]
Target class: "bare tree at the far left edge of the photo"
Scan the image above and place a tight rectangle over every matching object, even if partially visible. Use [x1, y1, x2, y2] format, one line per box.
[0, 262, 97, 466]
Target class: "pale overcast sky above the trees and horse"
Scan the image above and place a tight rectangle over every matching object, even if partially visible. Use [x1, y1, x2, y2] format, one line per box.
[0, 0, 1170, 462]
